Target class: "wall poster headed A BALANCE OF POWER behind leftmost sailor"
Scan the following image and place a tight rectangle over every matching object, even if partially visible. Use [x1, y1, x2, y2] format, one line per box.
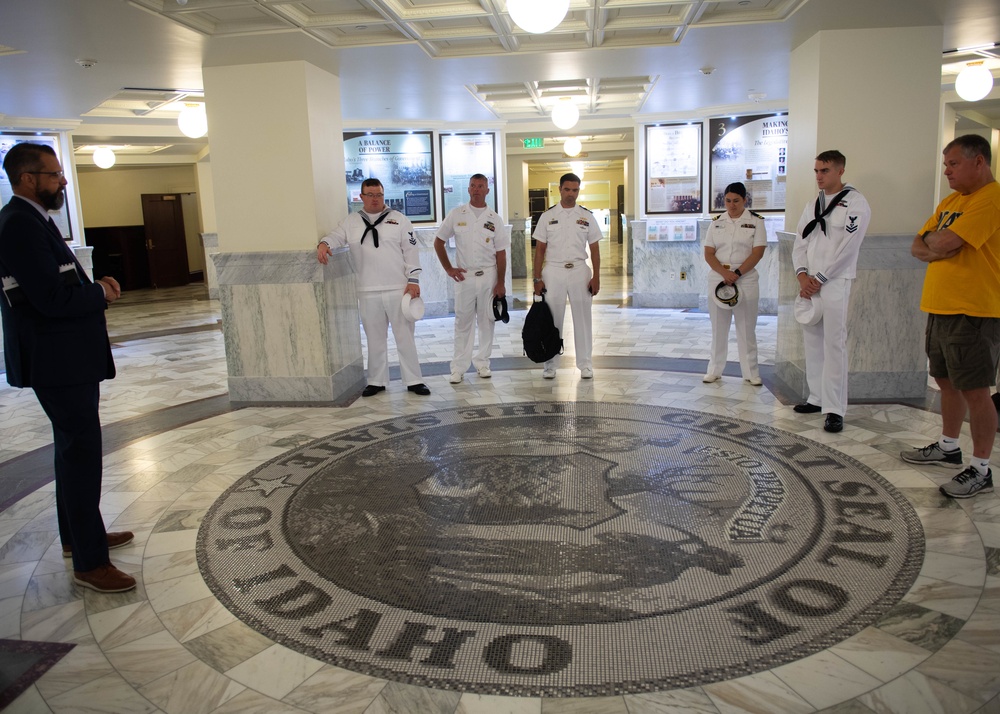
[344, 131, 435, 223]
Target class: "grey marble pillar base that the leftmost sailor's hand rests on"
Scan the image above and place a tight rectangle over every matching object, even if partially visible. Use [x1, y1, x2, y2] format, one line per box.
[211, 249, 365, 405]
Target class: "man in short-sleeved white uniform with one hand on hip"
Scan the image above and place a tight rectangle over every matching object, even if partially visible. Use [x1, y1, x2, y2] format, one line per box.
[434, 174, 510, 384]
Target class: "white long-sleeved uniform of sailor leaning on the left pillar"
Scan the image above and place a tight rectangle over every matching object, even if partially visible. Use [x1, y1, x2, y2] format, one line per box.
[322, 208, 423, 387]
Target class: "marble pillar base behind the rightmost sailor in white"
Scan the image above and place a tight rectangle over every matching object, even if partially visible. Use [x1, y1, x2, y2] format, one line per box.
[774, 232, 927, 401]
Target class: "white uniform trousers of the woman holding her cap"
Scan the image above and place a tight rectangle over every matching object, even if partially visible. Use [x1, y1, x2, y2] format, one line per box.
[705, 269, 760, 379]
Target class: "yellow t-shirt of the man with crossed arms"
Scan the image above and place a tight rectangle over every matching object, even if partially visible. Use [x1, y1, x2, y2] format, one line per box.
[920, 181, 1000, 317]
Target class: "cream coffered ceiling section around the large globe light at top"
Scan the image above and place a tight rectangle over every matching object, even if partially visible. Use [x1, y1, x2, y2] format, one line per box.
[130, 0, 807, 57]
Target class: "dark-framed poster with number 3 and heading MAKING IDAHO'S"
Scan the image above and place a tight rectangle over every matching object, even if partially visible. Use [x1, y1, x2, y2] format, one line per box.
[708, 114, 788, 212]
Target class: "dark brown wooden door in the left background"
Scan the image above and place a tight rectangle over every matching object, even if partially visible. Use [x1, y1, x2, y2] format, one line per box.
[142, 193, 191, 288]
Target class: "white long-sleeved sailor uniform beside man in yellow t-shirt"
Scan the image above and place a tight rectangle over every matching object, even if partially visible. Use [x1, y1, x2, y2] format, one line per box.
[792, 186, 871, 416]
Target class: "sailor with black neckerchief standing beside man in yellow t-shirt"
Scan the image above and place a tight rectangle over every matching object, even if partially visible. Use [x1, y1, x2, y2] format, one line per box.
[792, 150, 871, 432]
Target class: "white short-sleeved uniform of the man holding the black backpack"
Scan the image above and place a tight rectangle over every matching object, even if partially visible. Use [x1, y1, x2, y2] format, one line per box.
[532, 203, 601, 370]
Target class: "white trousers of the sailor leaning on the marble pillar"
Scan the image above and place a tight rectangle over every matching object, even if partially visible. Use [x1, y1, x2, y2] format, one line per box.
[358, 290, 423, 387]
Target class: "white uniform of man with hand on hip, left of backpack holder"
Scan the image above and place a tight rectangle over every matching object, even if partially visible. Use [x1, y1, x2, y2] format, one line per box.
[437, 203, 510, 374]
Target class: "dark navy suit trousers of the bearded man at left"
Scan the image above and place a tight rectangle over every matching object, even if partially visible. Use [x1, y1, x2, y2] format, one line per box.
[34, 382, 110, 572]
